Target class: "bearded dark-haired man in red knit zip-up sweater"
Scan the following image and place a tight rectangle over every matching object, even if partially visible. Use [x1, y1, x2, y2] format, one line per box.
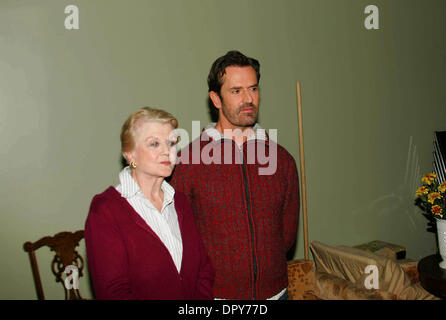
[171, 51, 300, 300]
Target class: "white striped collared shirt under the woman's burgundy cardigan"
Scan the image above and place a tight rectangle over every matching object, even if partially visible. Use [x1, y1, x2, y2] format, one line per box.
[115, 166, 183, 272]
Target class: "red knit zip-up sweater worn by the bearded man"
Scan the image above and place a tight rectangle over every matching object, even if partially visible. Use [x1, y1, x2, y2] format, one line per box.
[170, 132, 300, 299]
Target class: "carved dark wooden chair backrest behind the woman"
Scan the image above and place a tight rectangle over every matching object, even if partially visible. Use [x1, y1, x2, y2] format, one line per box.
[23, 230, 84, 300]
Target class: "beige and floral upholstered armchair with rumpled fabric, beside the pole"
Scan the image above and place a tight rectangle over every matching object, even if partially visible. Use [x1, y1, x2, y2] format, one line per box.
[288, 241, 438, 300]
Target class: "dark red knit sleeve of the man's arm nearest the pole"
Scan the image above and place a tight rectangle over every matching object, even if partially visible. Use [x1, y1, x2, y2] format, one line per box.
[283, 155, 300, 251]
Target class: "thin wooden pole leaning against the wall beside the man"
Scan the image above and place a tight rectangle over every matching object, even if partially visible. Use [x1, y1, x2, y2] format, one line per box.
[296, 82, 309, 260]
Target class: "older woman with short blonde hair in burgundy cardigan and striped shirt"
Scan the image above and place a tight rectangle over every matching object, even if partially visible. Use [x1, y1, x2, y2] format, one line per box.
[85, 107, 214, 299]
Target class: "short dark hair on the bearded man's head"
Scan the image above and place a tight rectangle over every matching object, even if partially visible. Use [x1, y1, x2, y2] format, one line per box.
[208, 50, 260, 96]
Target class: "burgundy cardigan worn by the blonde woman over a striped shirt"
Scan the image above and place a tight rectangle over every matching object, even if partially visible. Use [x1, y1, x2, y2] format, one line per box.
[85, 187, 214, 300]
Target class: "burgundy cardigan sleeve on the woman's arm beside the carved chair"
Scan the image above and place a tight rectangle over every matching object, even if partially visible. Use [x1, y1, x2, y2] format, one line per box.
[85, 197, 134, 300]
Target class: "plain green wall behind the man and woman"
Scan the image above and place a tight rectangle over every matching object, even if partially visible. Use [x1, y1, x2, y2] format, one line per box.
[0, 0, 446, 299]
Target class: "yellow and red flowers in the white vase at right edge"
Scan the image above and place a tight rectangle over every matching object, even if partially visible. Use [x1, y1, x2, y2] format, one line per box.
[415, 173, 446, 220]
